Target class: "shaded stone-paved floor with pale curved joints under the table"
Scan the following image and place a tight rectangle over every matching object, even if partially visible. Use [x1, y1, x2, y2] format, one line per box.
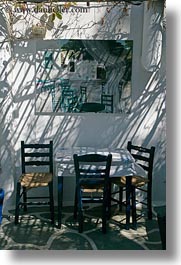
[0, 204, 162, 250]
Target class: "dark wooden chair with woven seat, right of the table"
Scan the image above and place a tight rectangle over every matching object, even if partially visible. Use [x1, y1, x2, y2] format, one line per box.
[111, 141, 155, 226]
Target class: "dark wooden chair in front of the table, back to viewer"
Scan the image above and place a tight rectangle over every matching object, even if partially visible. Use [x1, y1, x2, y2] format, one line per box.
[73, 154, 112, 233]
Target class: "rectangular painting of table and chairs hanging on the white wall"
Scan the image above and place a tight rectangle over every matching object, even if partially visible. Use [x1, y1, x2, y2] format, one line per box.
[36, 39, 133, 113]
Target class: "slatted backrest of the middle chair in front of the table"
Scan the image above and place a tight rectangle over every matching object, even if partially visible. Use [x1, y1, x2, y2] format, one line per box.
[73, 154, 112, 185]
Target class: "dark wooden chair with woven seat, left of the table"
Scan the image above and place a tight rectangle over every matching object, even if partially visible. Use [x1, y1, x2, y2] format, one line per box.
[15, 141, 54, 224]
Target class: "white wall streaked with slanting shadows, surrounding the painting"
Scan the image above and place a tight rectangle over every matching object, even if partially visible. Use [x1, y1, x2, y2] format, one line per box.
[0, 1, 166, 206]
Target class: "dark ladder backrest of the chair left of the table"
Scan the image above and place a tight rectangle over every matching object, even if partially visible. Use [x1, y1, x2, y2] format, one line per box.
[21, 141, 53, 174]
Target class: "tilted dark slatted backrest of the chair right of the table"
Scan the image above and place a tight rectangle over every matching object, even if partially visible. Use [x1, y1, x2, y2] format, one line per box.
[127, 141, 155, 184]
